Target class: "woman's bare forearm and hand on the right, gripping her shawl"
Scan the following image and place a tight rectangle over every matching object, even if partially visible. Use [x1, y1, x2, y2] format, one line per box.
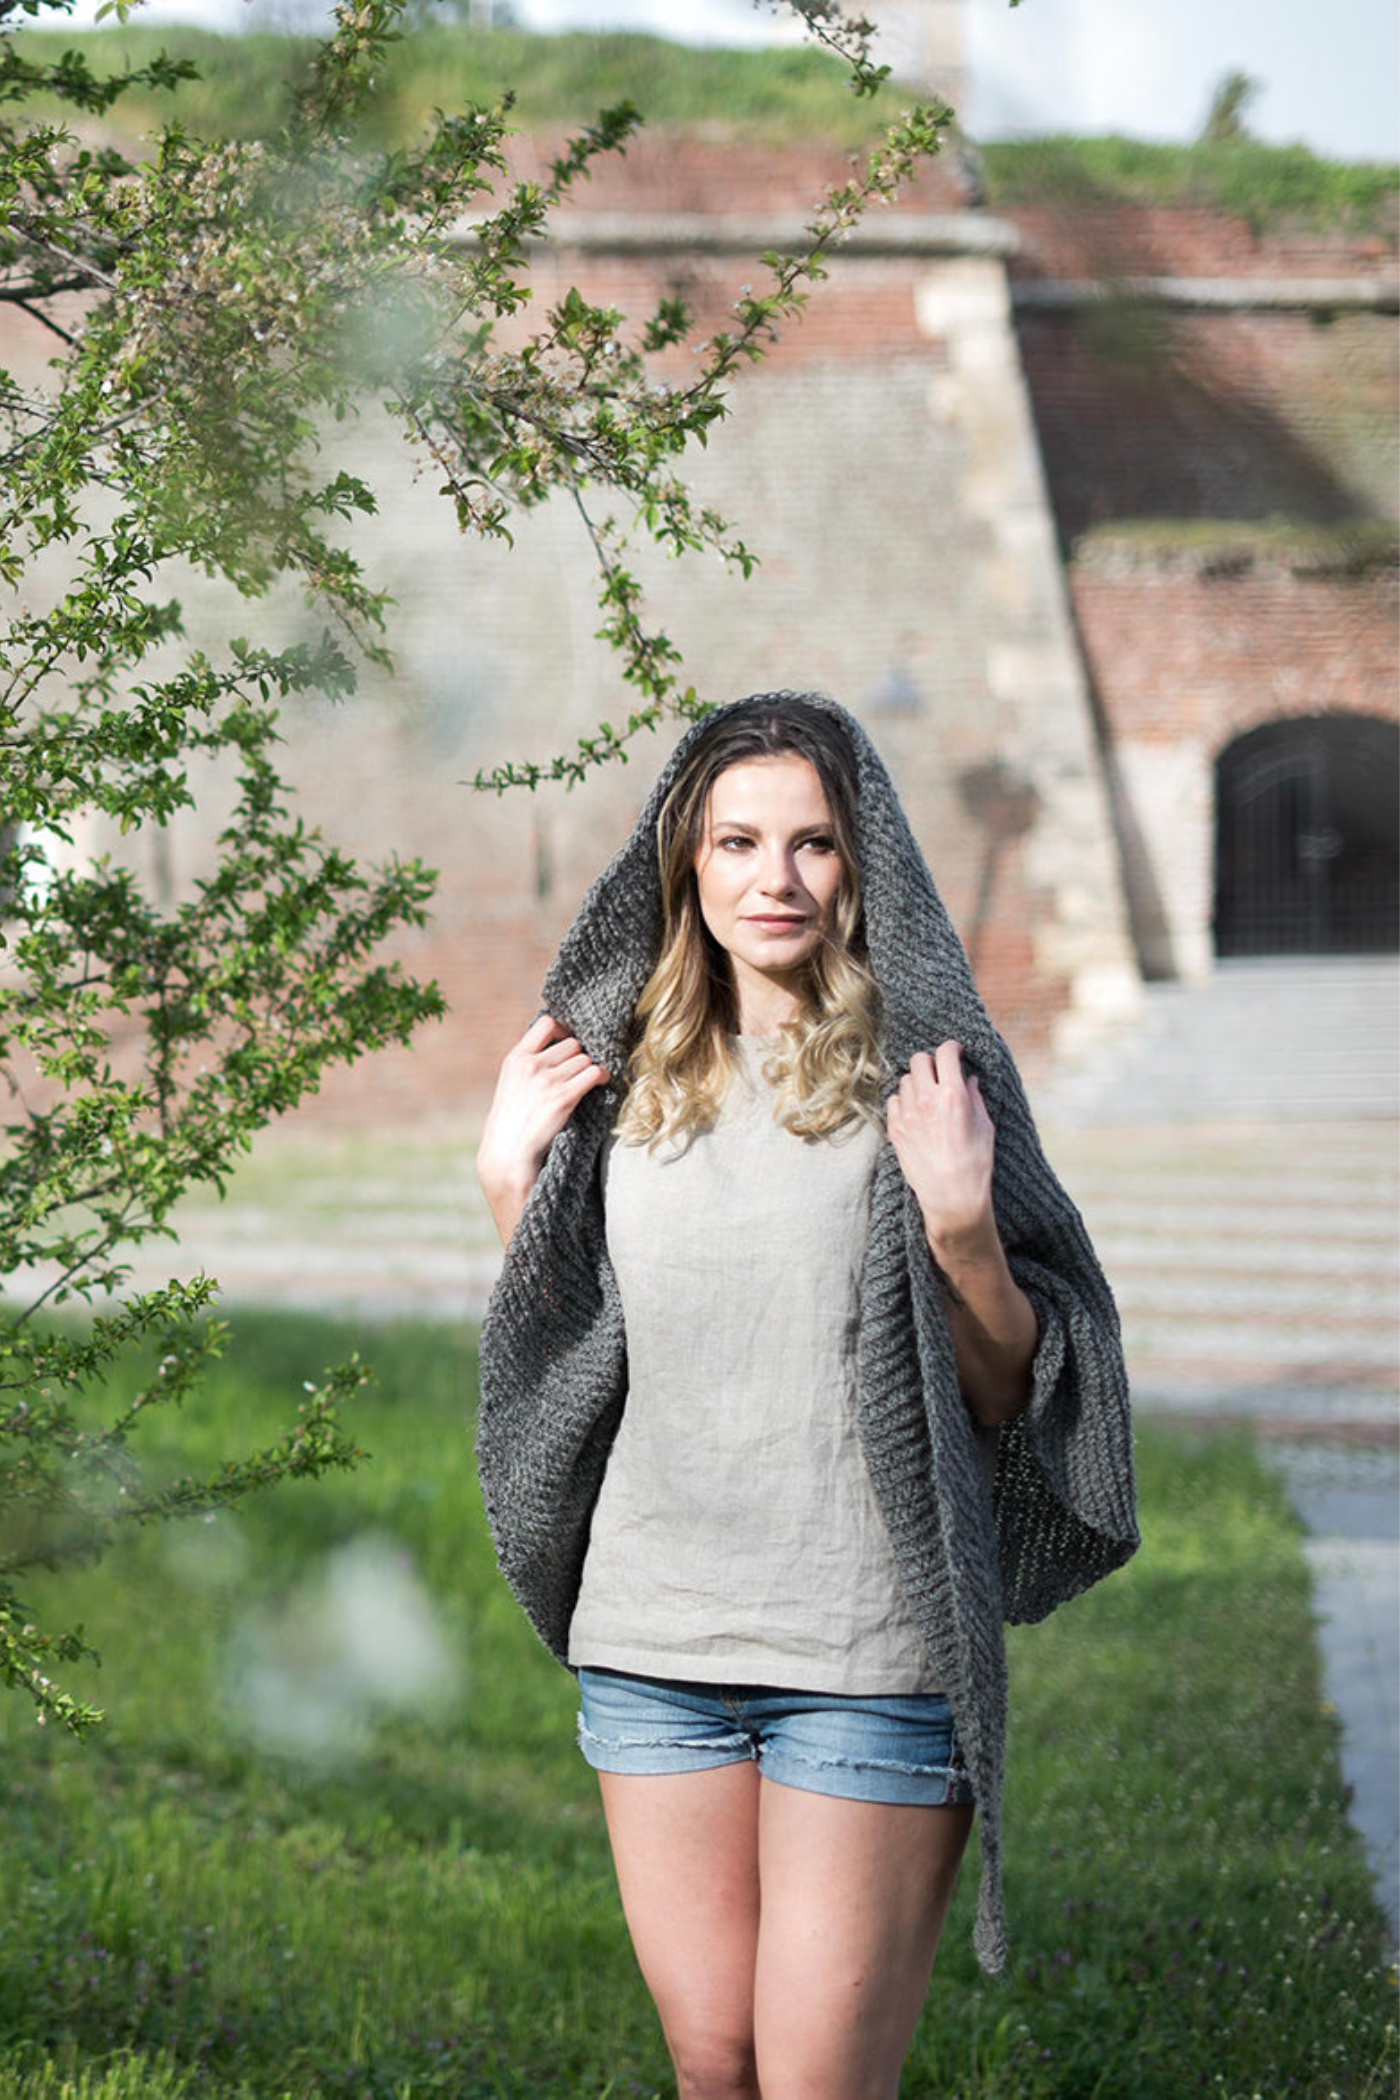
[888, 1042, 1039, 1426]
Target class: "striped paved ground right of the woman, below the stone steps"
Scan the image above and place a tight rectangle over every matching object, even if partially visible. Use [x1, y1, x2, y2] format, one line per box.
[1045, 1121, 1400, 1436]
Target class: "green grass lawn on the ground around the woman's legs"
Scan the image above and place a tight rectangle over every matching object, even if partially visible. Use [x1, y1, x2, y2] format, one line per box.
[0, 1315, 1396, 2100]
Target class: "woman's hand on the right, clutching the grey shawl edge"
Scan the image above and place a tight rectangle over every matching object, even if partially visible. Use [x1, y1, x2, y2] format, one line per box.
[886, 1042, 997, 1254]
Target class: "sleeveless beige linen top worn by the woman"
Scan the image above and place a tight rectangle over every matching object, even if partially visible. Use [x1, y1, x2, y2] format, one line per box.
[569, 1035, 938, 1693]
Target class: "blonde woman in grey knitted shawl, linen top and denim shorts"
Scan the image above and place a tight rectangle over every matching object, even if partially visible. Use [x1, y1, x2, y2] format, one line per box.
[479, 693, 1136, 2100]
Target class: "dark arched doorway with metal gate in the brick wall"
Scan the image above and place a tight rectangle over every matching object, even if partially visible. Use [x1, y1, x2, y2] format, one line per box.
[1215, 714, 1400, 956]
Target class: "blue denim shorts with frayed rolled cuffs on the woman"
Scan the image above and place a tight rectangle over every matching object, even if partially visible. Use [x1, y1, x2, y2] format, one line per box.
[579, 1670, 972, 1808]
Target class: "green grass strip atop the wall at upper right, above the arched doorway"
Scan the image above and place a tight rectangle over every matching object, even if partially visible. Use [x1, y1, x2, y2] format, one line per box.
[982, 134, 1400, 239]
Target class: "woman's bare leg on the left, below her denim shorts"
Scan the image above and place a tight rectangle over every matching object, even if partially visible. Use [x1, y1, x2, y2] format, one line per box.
[598, 1762, 770, 2100]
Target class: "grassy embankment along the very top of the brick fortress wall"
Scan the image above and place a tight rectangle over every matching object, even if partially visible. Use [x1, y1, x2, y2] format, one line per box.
[13, 23, 1400, 235]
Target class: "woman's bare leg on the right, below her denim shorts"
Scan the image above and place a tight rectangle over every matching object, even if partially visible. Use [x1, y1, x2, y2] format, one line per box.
[754, 1779, 972, 2100]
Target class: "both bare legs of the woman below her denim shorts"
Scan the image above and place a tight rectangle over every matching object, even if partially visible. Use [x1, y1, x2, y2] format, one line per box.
[598, 1764, 972, 2100]
